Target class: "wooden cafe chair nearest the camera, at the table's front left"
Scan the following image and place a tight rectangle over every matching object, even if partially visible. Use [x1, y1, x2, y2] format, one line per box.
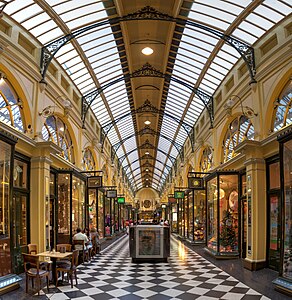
[22, 253, 50, 295]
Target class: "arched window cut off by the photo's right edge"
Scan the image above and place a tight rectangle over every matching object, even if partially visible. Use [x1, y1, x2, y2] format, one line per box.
[272, 79, 292, 131]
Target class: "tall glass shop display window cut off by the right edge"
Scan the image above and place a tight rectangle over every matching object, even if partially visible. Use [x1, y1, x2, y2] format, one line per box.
[274, 129, 292, 296]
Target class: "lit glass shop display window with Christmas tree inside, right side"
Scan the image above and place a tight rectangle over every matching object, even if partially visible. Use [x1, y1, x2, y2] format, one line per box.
[206, 171, 240, 258]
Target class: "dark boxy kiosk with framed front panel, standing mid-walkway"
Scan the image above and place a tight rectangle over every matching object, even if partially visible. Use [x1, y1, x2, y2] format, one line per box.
[129, 224, 170, 263]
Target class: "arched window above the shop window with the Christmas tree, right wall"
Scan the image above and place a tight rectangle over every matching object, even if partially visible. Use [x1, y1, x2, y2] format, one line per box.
[223, 115, 254, 162]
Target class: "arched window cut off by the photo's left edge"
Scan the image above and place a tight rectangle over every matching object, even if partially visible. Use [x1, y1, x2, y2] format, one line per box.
[0, 78, 26, 132]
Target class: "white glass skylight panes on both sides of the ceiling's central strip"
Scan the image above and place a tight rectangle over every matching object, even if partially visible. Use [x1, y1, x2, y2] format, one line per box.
[4, 0, 292, 190]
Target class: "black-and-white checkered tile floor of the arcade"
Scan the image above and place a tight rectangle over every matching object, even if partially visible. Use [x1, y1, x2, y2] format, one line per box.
[34, 236, 269, 300]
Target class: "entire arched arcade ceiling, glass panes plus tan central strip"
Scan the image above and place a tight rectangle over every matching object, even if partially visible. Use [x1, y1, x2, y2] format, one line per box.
[0, 0, 292, 195]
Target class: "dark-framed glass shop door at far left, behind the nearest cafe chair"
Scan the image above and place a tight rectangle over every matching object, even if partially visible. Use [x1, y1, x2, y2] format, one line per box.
[11, 192, 28, 274]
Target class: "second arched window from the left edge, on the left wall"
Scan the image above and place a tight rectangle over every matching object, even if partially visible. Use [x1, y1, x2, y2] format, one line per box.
[42, 116, 75, 163]
